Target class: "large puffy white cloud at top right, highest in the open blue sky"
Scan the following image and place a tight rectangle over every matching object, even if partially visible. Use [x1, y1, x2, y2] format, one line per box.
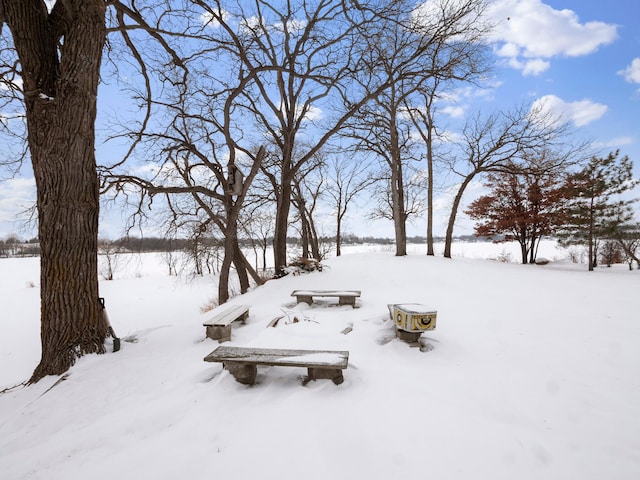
[488, 0, 617, 75]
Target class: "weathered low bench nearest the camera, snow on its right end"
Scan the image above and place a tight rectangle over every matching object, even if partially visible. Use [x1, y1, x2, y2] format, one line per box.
[204, 346, 349, 385]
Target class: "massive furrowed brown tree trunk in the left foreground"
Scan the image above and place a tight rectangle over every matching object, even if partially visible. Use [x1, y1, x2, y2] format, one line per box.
[1, 0, 107, 383]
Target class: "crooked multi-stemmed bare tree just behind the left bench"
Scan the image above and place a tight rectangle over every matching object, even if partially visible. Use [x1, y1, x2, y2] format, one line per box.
[97, 1, 276, 303]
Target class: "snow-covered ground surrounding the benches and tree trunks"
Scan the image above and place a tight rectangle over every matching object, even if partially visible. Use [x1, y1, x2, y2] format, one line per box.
[0, 244, 640, 480]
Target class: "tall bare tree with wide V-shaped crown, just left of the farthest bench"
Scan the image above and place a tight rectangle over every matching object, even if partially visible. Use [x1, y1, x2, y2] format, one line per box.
[189, 0, 416, 269]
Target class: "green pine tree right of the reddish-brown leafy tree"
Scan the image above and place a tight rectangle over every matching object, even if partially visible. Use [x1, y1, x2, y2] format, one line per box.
[559, 151, 638, 271]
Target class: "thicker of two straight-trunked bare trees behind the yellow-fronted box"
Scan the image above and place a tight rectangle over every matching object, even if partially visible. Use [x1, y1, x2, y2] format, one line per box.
[342, 0, 488, 255]
